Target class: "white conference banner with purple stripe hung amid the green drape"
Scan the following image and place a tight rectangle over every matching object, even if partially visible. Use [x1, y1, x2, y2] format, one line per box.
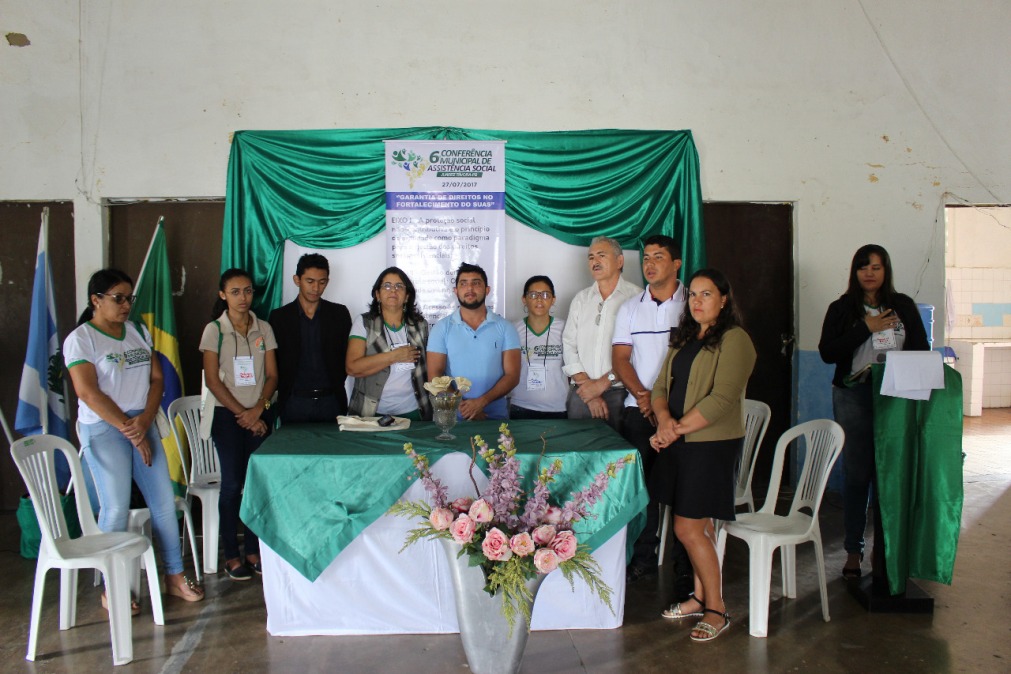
[385, 140, 506, 323]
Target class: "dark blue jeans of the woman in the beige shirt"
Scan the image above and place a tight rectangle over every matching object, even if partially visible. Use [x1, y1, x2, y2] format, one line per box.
[210, 407, 266, 560]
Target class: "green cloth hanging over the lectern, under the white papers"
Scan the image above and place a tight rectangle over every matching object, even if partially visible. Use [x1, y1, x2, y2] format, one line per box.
[871, 365, 962, 594]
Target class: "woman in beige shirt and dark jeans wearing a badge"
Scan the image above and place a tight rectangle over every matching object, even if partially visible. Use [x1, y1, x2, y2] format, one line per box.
[200, 269, 277, 581]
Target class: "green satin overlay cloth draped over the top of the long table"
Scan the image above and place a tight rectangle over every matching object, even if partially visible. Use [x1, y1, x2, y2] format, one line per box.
[241, 420, 649, 581]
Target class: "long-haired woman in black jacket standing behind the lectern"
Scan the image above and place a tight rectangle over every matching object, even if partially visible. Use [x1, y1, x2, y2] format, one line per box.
[818, 244, 929, 578]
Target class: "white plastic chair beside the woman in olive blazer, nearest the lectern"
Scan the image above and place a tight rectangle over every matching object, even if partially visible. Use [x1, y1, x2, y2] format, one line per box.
[723, 419, 844, 637]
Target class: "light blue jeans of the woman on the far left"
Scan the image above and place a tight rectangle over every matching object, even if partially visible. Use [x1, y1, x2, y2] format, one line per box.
[81, 409, 183, 575]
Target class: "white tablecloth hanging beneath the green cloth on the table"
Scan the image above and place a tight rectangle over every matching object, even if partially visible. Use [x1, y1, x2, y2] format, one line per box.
[261, 454, 625, 637]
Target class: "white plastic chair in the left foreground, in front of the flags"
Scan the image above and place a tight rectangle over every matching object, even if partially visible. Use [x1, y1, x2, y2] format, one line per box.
[10, 436, 165, 665]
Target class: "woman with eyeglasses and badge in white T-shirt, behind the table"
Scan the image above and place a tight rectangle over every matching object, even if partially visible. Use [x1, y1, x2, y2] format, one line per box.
[509, 276, 568, 419]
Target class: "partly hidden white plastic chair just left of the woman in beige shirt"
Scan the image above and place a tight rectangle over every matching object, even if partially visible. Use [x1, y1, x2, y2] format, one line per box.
[169, 395, 221, 573]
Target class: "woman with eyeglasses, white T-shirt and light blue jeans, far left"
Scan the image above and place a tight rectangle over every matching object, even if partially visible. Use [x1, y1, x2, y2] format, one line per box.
[64, 269, 203, 615]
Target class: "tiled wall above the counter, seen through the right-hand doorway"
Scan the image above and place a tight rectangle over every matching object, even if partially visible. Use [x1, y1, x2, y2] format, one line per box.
[934, 267, 1011, 340]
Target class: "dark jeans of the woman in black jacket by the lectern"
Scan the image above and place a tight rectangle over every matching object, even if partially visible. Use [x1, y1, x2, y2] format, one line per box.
[832, 383, 875, 555]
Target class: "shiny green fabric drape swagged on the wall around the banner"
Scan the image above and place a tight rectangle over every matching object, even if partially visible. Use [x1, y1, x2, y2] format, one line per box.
[221, 126, 706, 315]
